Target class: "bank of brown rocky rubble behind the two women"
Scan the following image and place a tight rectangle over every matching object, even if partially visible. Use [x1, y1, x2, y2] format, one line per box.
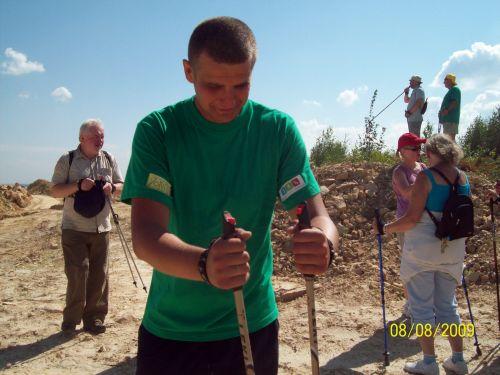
[272, 163, 495, 285]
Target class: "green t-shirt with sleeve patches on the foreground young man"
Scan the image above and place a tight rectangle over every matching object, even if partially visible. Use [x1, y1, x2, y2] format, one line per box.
[122, 97, 319, 342]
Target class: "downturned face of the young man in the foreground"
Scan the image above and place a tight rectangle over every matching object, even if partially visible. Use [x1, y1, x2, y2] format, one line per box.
[183, 52, 253, 124]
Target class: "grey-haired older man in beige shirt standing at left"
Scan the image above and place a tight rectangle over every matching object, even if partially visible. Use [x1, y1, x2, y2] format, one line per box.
[51, 119, 123, 334]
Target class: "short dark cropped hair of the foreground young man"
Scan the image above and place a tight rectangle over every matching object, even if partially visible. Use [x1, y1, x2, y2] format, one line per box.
[188, 17, 257, 65]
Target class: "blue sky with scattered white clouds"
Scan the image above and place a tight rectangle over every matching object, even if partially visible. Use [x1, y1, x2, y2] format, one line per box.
[0, 0, 500, 183]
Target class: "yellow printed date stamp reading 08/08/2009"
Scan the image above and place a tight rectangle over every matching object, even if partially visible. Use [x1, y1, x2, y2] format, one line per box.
[389, 323, 474, 338]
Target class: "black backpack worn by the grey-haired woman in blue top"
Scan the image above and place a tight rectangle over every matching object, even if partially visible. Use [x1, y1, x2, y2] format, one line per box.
[425, 168, 474, 241]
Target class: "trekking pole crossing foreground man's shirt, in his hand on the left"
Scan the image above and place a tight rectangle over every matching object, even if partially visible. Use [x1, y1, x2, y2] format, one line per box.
[222, 211, 255, 375]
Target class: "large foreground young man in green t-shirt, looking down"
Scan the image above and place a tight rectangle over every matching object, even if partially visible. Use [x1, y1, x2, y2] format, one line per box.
[122, 17, 338, 374]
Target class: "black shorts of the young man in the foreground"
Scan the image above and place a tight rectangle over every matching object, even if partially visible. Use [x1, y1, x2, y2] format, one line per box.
[136, 320, 279, 375]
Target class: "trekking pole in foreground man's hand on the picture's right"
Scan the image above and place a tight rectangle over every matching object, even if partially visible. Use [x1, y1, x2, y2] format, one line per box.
[297, 203, 319, 375]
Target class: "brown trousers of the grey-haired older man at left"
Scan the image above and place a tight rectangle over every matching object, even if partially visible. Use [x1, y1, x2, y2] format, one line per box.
[62, 229, 109, 324]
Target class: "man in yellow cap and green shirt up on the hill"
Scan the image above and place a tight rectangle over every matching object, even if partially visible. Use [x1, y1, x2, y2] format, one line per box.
[439, 74, 462, 140]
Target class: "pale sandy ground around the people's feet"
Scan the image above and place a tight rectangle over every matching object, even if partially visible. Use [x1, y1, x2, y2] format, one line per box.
[0, 196, 500, 374]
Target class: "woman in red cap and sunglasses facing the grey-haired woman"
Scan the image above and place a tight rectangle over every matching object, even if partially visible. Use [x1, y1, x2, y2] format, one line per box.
[392, 133, 426, 319]
